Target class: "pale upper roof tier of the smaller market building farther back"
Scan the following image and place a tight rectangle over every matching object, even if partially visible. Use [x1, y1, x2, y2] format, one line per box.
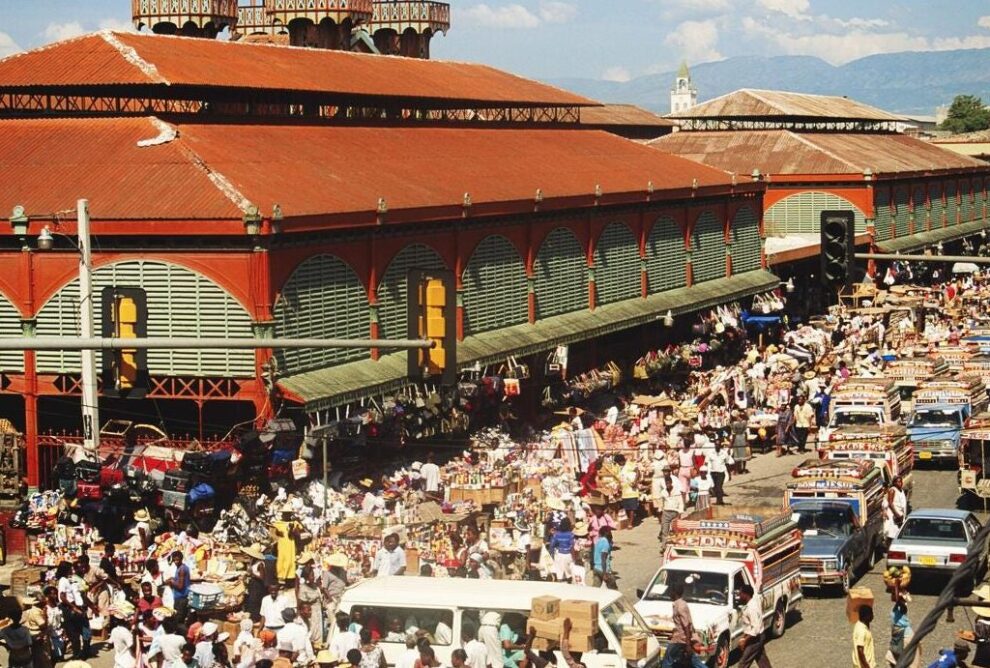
[669, 88, 906, 121]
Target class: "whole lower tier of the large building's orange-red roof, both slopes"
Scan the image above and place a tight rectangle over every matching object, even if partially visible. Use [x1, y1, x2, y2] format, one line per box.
[0, 118, 730, 220]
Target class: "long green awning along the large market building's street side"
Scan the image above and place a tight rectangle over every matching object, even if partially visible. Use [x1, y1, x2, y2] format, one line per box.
[278, 271, 780, 411]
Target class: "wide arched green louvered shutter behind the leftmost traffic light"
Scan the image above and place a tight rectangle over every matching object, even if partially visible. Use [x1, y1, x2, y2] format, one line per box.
[36, 260, 255, 378]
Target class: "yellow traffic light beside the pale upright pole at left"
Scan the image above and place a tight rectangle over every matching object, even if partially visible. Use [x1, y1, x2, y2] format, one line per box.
[102, 287, 149, 399]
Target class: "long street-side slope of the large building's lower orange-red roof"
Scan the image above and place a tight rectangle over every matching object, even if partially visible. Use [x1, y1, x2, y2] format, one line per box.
[180, 120, 730, 216]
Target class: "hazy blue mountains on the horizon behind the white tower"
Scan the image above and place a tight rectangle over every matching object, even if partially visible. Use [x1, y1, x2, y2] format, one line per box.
[551, 49, 990, 115]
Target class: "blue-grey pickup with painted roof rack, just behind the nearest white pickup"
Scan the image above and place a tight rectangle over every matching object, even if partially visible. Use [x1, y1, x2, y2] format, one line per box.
[784, 459, 885, 594]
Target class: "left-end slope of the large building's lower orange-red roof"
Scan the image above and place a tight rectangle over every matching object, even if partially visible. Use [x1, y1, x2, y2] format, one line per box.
[0, 118, 243, 220]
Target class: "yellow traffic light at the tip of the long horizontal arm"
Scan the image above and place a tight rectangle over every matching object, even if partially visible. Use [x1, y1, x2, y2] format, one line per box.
[407, 269, 457, 386]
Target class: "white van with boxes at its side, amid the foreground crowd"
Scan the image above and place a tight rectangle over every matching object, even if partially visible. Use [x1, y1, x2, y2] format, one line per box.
[328, 576, 660, 668]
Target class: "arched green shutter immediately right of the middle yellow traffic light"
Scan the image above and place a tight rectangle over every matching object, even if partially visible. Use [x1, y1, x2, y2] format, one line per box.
[462, 234, 529, 336]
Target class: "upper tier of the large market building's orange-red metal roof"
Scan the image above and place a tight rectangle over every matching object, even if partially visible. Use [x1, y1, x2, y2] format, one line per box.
[0, 32, 598, 106]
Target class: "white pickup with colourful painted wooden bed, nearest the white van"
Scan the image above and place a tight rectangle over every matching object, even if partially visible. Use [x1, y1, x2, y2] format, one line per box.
[634, 506, 802, 668]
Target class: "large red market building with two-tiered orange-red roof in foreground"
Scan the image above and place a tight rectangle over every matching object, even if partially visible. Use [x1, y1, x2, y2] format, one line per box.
[0, 32, 779, 485]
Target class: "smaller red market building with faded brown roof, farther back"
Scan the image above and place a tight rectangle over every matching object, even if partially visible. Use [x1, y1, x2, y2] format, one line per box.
[651, 89, 990, 306]
